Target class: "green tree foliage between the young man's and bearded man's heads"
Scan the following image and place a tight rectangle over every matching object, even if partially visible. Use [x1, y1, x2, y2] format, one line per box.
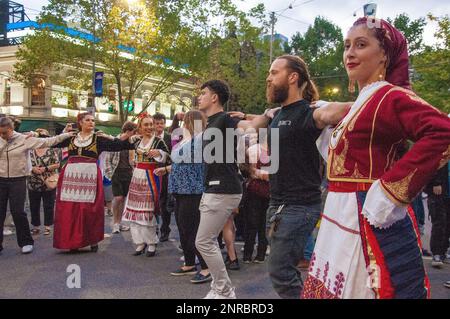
[200, 4, 283, 113]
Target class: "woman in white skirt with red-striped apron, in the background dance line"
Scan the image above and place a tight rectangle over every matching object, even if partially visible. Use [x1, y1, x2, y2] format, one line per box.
[123, 113, 169, 257]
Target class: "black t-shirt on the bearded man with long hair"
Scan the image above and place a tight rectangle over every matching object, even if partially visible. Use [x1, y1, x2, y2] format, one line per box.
[269, 100, 321, 206]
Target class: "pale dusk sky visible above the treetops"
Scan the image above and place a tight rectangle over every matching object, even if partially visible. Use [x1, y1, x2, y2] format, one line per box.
[16, 0, 450, 44]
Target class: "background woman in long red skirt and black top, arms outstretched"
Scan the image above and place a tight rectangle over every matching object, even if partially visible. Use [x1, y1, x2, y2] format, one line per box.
[53, 113, 134, 252]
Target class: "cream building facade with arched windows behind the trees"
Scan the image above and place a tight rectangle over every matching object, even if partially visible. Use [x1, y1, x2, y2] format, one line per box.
[0, 45, 195, 134]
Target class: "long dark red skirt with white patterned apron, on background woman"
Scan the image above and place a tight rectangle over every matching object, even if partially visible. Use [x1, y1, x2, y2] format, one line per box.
[53, 156, 105, 249]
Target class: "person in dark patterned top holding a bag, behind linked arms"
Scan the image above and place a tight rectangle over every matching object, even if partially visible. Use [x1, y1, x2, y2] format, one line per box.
[27, 129, 61, 236]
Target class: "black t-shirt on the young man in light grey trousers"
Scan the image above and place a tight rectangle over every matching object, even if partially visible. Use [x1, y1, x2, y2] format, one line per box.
[203, 112, 242, 194]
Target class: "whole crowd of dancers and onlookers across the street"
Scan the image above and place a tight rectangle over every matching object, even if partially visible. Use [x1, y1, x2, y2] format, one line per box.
[0, 18, 450, 299]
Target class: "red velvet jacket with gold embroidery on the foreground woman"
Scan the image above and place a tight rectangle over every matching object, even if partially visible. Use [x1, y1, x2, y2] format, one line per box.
[327, 85, 450, 204]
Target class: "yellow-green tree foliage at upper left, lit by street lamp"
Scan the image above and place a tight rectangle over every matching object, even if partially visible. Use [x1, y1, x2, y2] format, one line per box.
[15, 0, 234, 122]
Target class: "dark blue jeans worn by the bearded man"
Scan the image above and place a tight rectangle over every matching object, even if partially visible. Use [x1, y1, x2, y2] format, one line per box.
[267, 204, 321, 299]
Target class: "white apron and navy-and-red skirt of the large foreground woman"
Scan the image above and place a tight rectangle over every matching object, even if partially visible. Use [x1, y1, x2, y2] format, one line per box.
[302, 192, 429, 299]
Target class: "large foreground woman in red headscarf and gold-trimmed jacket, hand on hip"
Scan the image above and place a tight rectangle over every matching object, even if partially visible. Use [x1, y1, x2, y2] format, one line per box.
[302, 18, 450, 298]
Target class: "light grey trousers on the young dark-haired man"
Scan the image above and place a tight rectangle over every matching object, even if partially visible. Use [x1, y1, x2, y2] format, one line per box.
[195, 193, 242, 296]
